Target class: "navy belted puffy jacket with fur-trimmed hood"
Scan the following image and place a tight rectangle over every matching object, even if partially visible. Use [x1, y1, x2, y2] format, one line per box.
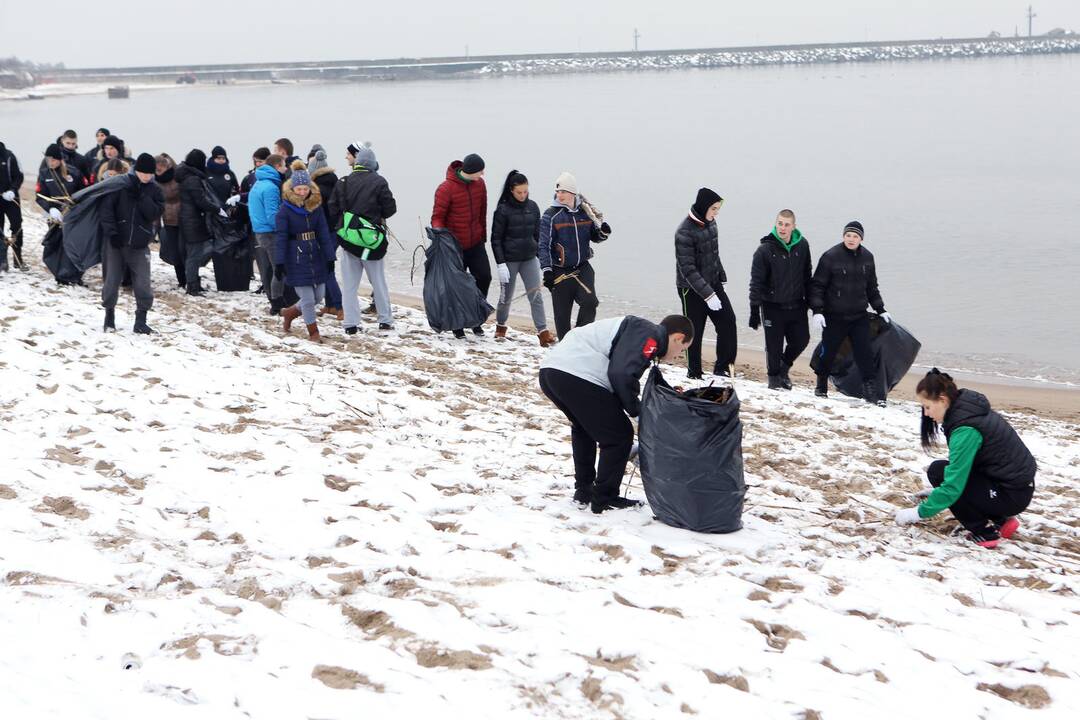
[273, 182, 337, 287]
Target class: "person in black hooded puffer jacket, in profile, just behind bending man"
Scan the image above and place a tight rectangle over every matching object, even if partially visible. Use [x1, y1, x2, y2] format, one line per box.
[675, 188, 738, 380]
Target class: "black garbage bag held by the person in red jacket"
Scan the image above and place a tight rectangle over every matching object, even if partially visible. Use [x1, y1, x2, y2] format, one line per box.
[423, 228, 495, 332]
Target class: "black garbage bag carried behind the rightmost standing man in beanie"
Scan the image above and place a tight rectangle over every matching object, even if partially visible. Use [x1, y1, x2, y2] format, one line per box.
[810, 315, 922, 397]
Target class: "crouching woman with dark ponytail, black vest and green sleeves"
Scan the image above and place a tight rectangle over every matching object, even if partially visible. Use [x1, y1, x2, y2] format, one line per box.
[895, 368, 1038, 548]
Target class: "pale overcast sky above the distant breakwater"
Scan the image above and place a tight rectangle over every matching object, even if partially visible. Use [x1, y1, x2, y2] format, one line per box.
[0, 0, 1080, 67]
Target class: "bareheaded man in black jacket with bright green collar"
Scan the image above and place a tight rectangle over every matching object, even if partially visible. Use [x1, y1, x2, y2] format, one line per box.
[750, 209, 811, 390]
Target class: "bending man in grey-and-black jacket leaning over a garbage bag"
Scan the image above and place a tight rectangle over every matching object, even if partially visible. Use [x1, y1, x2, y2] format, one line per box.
[540, 315, 693, 514]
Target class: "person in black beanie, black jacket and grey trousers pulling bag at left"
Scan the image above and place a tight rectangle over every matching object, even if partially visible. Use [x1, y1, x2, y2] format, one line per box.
[99, 152, 165, 335]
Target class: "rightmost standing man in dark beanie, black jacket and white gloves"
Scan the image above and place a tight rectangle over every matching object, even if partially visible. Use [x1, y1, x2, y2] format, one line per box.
[810, 220, 892, 407]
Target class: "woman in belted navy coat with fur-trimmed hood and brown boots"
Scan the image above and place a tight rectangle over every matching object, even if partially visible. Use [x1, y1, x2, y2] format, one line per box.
[273, 160, 336, 342]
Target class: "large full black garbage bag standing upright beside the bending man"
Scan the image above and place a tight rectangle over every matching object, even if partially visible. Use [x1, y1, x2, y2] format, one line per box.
[638, 367, 746, 532]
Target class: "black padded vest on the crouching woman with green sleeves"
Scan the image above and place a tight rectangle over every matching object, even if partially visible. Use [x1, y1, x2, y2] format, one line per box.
[942, 390, 1037, 489]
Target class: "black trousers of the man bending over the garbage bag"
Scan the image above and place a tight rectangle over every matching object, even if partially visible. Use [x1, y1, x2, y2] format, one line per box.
[540, 368, 634, 502]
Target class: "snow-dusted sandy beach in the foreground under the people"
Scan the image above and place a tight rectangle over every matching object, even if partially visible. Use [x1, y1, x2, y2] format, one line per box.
[0, 218, 1080, 720]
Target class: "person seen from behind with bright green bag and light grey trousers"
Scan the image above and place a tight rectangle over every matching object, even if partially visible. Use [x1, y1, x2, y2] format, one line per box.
[326, 142, 397, 335]
